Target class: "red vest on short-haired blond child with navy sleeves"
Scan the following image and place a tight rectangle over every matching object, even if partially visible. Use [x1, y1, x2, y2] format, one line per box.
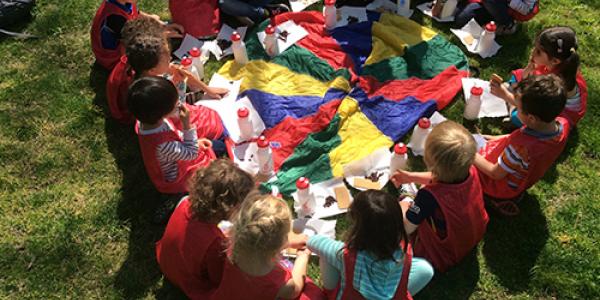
[415, 166, 489, 272]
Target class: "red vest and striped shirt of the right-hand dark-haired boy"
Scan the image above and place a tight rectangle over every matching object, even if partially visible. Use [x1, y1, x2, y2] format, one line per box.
[479, 117, 571, 199]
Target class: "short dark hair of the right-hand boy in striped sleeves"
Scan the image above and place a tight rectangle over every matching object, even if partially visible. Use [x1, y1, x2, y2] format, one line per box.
[516, 74, 567, 122]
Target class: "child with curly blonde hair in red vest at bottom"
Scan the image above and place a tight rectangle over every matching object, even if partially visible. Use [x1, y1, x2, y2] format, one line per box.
[212, 193, 325, 300]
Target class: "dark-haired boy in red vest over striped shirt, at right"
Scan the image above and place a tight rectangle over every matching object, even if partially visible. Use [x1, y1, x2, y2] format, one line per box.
[475, 74, 571, 215]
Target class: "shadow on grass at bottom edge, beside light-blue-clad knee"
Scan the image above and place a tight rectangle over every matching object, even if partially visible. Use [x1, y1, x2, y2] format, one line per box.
[415, 247, 479, 299]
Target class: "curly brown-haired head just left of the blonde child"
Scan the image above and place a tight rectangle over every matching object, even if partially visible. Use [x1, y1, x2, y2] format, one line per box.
[189, 159, 254, 223]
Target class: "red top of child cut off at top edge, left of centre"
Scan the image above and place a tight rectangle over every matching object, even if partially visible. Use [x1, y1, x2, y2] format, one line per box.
[169, 0, 221, 37]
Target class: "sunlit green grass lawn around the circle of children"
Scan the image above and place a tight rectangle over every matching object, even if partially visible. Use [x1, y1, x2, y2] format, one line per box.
[0, 0, 600, 299]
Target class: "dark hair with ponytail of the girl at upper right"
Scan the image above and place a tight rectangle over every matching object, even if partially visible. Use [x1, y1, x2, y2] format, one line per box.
[537, 26, 580, 91]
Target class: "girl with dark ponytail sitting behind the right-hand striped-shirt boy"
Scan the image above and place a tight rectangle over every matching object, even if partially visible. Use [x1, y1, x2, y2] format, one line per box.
[490, 26, 587, 127]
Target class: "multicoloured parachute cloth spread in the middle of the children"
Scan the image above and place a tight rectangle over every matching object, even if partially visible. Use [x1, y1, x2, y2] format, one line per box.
[219, 12, 468, 195]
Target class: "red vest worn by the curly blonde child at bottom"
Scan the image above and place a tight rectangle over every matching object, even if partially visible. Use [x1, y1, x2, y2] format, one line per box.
[211, 260, 325, 300]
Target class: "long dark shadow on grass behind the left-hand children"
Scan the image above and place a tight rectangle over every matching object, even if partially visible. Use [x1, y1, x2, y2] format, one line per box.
[90, 62, 172, 299]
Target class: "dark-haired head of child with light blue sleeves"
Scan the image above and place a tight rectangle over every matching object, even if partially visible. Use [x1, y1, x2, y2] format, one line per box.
[345, 190, 408, 260]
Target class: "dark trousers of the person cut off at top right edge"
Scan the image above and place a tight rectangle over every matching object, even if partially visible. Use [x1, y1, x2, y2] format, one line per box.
[454, 0, 513, 28]
